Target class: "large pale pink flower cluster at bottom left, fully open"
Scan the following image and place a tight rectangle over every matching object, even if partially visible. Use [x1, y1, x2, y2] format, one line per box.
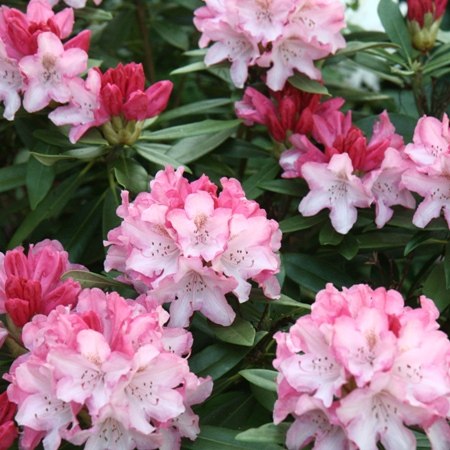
[6, 289, 212, 450]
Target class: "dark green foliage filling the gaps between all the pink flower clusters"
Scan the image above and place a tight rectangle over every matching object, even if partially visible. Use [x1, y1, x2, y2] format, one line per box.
[0, 0, 450, 450]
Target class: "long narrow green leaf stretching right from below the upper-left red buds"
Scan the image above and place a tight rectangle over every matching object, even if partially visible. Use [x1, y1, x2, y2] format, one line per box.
[140, 119, 242, 141]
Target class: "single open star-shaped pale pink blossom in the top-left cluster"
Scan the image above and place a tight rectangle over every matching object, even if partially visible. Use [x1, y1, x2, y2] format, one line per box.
[19, 32, 87, 112]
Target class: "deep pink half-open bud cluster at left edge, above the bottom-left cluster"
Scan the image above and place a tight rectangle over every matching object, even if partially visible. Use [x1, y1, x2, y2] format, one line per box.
[0, 239, 82, 327]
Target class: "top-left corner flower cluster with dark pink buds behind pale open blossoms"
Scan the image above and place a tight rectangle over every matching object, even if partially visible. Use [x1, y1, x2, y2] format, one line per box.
[0, 0, 90, 120]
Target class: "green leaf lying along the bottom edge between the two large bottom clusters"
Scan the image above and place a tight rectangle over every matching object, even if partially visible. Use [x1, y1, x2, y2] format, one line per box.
[183, 425, 281, 450]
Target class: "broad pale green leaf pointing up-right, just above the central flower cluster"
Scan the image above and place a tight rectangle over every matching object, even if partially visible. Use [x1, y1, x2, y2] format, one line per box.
[167, 129, 234, 164]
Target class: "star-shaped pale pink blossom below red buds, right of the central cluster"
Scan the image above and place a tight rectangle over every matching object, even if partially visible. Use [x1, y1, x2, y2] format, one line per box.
[299, 153, 372, 234]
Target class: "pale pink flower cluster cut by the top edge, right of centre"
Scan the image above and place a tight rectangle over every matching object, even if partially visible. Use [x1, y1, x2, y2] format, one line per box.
[194, 0, 345, 91]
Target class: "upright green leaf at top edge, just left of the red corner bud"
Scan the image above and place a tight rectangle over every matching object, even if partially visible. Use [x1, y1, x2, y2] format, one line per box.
[378, 0, 416, 61]
